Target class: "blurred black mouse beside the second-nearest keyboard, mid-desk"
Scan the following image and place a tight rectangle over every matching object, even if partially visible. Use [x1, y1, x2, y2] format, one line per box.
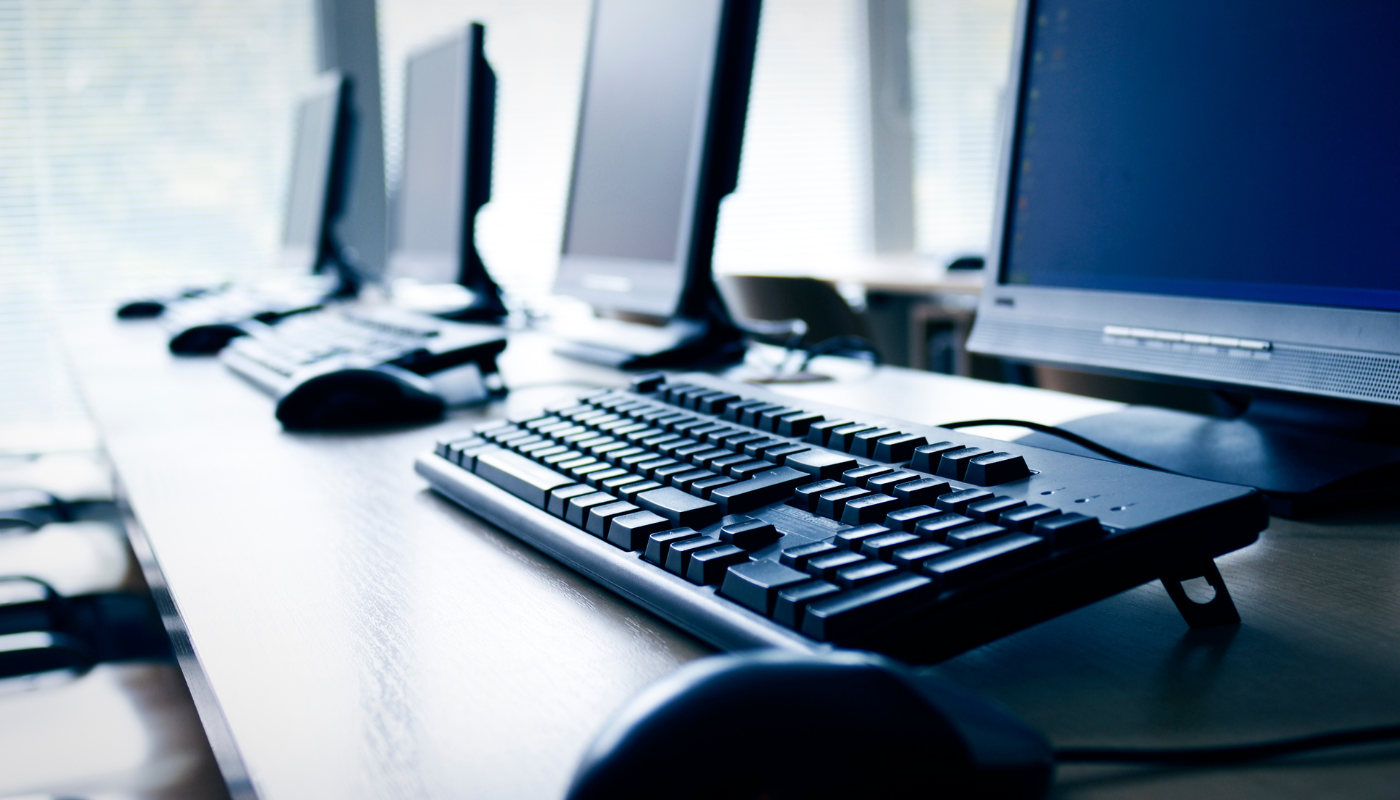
[277, 366, 445, 430]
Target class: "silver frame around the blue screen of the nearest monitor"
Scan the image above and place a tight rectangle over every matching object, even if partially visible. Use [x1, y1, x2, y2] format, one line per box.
[967, 0, 1400, 405]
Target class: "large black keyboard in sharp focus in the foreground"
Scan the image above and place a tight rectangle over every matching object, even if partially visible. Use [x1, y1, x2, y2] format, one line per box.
[416, 374, 1267, 663]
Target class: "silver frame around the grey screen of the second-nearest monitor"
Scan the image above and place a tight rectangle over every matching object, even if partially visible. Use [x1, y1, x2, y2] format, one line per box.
[553, 0, 735, 321]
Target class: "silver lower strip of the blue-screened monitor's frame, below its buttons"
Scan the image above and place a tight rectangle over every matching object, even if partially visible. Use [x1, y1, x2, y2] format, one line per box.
[969, 319, 1400, 405]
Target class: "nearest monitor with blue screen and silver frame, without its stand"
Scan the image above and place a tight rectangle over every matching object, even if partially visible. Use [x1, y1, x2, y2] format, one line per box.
[969, 0, 1400, 405]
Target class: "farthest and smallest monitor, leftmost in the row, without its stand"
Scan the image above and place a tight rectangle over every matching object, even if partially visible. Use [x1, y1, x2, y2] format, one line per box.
[279, 71, 350, 273]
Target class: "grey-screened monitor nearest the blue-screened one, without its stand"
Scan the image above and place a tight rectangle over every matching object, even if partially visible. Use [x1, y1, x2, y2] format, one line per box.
[554, 0, 757, 318]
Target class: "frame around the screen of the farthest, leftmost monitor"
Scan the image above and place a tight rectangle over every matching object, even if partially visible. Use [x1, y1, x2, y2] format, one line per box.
[277, 70, 350, 273]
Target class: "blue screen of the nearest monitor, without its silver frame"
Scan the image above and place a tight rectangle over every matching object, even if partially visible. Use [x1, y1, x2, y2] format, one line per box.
[1001, 0, 1400, 316]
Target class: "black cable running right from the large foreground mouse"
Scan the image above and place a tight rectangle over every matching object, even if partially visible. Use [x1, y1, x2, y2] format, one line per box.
[1054, 724, 1400, 766]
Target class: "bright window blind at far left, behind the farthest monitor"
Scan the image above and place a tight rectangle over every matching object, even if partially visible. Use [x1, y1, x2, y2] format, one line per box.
[0, 0, 315, 447]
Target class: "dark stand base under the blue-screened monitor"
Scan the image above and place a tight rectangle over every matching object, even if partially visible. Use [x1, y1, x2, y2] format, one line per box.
[1018, 395, 1400, 517]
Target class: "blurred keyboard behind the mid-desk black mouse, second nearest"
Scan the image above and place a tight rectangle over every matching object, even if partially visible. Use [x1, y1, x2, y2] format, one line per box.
[220, 304, 505, 405]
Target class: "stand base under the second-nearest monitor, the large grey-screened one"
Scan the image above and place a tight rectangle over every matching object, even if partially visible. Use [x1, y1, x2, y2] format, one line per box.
[554, 296, 743, 370]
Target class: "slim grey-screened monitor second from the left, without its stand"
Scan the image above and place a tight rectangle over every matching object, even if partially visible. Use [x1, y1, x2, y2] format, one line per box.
[388, 24, 496, 294]
